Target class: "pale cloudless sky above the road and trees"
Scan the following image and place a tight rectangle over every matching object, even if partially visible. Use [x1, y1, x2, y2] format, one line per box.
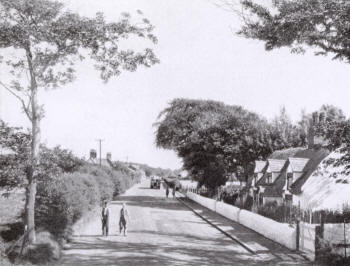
[0, 0, 350, 169]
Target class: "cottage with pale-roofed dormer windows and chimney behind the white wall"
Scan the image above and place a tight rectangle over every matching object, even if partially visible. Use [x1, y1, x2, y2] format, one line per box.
[248, 112, 330, 205]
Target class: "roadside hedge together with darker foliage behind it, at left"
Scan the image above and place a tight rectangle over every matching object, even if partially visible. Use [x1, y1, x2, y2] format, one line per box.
[0, 121, 140, 237]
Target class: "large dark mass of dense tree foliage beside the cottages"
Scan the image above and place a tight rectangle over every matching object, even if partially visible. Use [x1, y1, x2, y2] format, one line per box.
[156, 99, 305, 190]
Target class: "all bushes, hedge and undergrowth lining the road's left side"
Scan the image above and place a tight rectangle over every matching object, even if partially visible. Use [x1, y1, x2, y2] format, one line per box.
[0, 122, 141, 264]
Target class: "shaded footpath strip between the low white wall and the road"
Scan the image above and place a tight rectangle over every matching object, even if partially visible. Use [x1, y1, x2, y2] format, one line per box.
[177, 193, 315, 265]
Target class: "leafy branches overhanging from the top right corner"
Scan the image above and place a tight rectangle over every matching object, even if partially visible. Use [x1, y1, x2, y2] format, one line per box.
[238, 0, 350, 63]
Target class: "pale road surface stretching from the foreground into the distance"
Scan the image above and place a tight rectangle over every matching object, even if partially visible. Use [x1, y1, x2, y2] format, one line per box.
[60, 180, 310, 266]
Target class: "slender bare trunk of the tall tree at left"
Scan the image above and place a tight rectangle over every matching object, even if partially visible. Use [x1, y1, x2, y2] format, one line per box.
[25, 45, 41, 244]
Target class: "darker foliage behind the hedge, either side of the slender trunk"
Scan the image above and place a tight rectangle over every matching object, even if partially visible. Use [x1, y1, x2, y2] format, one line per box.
[0, 120, 83, 189]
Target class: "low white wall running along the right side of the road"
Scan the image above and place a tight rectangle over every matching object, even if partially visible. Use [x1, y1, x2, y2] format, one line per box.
[187, 192, 296, 249]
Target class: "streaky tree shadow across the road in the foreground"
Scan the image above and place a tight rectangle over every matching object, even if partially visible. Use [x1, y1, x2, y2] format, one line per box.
[60, 231, 284, 266]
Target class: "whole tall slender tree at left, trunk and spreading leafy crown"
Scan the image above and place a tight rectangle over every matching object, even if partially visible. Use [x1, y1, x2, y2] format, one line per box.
[0, 0, 158, 243]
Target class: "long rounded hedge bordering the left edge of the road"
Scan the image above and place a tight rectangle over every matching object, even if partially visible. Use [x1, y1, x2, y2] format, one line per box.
[35, 161, 139, 239]
